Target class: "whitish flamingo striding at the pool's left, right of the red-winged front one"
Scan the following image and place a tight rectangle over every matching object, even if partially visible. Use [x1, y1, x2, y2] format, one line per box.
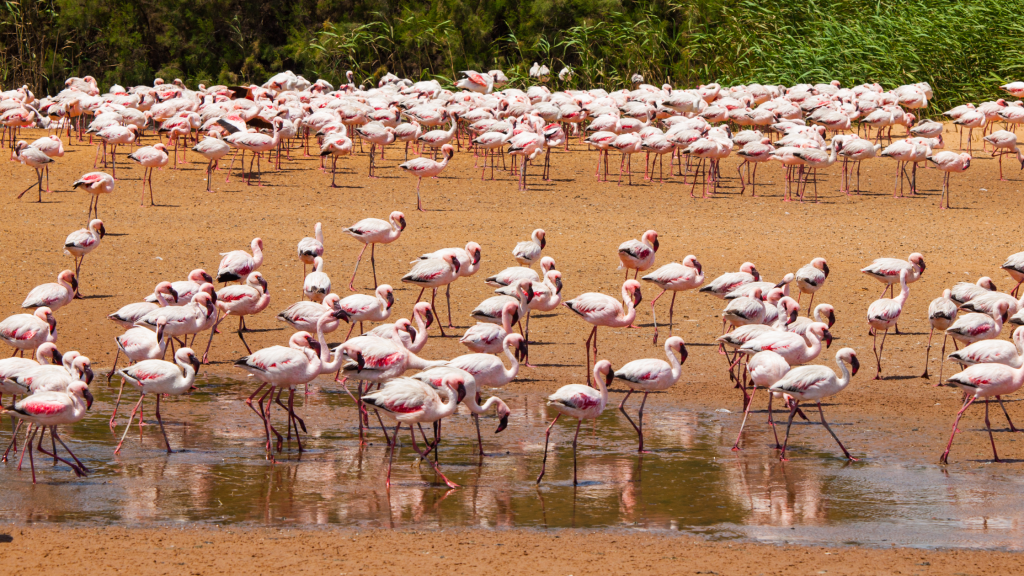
[112, 348, 200, 454]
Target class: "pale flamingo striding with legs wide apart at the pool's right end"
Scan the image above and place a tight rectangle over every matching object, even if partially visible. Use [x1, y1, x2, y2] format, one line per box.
[768, 348, 860, 461]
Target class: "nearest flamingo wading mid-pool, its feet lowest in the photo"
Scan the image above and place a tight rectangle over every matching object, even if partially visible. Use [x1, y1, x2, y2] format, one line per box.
[359, 375, 466, 489]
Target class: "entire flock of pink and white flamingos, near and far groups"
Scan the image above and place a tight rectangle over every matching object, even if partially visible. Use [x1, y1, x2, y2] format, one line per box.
[0, 71, 1024, 488]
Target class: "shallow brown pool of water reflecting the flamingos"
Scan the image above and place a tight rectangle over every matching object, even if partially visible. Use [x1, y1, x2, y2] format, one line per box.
[0, 378, 1024, 549]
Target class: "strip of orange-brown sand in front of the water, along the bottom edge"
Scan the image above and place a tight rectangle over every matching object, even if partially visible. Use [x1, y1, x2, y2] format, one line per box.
[8, 527, 1021, 576]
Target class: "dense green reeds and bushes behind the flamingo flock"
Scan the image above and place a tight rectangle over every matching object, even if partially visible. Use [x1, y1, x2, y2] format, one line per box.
[0, 0, 1024, 106]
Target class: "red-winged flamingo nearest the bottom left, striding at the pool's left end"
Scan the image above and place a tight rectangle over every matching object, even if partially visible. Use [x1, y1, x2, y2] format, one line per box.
[0, 381, 92, 484]
